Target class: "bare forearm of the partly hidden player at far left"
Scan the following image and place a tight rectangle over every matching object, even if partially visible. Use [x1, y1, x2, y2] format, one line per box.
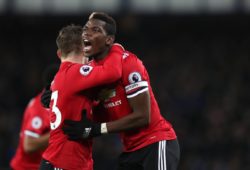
[24, 133, 49, 153]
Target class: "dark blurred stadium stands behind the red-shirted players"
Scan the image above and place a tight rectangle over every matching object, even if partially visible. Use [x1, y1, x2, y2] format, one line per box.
[0, 0, 250, 170]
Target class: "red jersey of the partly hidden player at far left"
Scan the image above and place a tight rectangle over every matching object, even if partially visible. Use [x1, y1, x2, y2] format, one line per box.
[11, 94, 50, 170]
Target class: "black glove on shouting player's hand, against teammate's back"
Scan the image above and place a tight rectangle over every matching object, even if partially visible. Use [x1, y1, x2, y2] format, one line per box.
[62, 109, 101, 140]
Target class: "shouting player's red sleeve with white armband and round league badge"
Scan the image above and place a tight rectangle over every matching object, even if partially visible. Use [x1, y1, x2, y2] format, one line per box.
[122, 52, 149, 98]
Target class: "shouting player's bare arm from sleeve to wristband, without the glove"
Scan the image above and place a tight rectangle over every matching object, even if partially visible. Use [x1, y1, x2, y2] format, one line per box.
[107, 91, 150, 133]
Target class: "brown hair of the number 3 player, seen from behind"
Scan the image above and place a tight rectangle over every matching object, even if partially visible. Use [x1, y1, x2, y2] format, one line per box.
[56, 24, 83, 54]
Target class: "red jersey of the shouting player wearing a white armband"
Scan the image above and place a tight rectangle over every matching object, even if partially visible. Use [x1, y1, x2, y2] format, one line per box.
[92, 51, 176, 152]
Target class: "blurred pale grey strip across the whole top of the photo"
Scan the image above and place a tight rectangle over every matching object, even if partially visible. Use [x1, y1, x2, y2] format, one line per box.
[0, 0, 247, 15]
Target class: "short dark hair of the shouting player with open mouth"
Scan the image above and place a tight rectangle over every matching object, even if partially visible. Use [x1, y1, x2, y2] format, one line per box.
[89, 12, 116, 36]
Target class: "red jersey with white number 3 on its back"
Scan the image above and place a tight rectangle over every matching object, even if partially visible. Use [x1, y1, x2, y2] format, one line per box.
[43, 46, 123, 170]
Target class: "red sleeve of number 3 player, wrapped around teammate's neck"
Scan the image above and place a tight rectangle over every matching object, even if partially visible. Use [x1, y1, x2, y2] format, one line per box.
[66, 45, 124, 91]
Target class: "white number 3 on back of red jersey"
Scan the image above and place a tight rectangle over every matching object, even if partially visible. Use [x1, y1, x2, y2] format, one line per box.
[50, 91, 62, 130]
